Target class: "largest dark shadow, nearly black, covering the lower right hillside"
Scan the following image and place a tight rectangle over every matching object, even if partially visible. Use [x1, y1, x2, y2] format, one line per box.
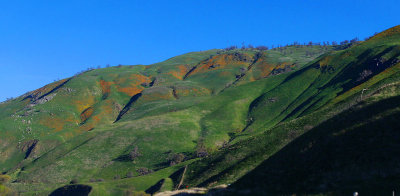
[230, 96, 400, 195]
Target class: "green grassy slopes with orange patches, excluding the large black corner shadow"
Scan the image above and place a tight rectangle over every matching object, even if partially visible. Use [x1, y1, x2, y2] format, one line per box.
[0, 24, 399, 194]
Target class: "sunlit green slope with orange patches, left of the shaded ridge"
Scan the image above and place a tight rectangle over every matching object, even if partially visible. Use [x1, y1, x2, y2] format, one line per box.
[0, 46, 332, 193]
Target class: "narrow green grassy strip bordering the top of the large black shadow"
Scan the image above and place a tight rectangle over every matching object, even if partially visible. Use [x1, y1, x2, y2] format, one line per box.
[185, 66, 400, 189]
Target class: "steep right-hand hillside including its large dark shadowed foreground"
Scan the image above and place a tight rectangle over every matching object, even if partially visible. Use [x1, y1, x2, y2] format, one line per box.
[186, 27, 400, 195]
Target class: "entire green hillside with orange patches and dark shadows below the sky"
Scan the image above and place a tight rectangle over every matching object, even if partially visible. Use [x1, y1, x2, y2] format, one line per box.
[0, 26, 400, 195]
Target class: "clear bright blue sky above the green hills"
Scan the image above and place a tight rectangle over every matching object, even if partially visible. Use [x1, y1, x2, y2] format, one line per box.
[0, 0, 400, 101]
